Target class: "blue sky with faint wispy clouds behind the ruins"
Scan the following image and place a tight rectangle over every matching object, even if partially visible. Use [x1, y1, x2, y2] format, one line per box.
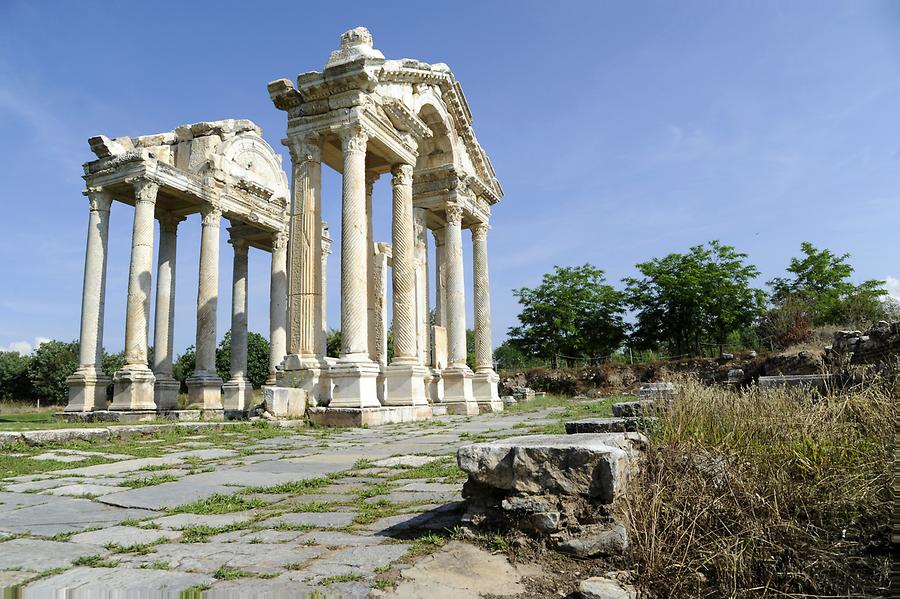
[0, 0, 900, 353]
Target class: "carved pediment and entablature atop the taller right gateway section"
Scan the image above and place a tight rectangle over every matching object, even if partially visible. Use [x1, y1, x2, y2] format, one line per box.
[269, 27, 503, 221]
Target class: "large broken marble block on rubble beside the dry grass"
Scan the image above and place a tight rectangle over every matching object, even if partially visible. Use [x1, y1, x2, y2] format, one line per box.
[456, 432, 647, 557]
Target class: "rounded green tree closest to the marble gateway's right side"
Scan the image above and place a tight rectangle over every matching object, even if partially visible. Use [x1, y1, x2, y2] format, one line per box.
[509, 264, 627, 368]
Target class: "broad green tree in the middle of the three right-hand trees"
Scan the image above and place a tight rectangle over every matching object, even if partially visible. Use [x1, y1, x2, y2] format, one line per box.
[624, 241, 765, 354]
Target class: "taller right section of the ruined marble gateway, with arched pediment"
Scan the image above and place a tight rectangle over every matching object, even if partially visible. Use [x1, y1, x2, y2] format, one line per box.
[269, 27, 503, 424]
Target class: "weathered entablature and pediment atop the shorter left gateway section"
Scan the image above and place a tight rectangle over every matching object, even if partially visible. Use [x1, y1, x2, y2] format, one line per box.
[84, 119, 290, 246]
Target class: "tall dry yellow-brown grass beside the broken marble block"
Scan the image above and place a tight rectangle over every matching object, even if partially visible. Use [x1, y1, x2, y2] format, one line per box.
[626, 380, 896, 597]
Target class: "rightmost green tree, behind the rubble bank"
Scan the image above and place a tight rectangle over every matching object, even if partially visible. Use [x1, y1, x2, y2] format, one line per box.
[769, 241, 890, 326]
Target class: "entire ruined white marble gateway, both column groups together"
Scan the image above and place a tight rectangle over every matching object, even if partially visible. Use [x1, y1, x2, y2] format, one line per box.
[66, 28, 503, 426]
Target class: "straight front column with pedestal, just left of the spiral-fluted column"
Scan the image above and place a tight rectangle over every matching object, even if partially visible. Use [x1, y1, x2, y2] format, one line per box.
[329, 125, 381, 408]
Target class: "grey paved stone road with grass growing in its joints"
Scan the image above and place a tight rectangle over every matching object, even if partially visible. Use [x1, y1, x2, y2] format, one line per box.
[0, 410, 553, 598]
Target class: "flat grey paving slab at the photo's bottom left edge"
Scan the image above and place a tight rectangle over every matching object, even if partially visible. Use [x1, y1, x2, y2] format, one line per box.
[24, 568, 215, 599]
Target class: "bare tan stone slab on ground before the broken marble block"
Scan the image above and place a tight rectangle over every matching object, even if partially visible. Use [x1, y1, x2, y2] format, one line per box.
[388, 541, 540, 599]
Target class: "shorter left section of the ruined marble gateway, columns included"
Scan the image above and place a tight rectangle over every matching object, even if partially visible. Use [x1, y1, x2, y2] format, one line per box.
[66, 120, 288, 417]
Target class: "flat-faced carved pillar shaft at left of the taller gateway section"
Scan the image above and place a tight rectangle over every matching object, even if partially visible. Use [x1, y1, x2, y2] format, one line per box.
[287, 135, 325, 360]
